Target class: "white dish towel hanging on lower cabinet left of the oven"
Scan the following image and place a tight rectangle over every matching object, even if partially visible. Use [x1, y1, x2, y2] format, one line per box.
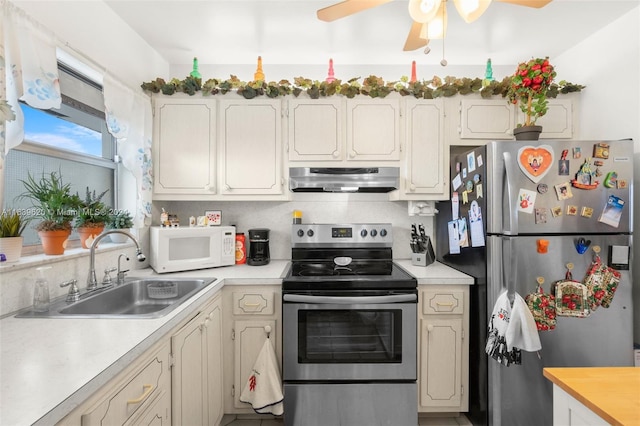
[240, 338, 284, 416]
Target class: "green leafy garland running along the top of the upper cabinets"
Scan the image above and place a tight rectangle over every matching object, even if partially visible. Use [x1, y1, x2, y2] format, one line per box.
[141, 75, 585, 99]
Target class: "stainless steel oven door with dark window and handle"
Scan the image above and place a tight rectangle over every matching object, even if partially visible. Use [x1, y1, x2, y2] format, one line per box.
[283, 293, 417, 382]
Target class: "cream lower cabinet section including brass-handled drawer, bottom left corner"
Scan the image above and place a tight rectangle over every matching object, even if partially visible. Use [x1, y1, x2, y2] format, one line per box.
[58, 341, 171, 426]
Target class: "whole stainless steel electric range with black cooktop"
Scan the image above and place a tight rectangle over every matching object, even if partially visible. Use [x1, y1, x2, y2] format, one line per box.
[282, 223, 418, 426]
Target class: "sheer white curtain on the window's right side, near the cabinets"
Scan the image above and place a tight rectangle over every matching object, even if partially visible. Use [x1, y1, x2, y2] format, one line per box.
[103, 75, 153, 228]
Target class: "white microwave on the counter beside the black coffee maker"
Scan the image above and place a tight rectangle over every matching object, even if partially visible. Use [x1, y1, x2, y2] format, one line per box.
[149, 226, 236, 274]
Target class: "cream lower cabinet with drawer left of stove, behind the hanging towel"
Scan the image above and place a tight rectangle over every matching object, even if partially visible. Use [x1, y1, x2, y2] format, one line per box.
[222, 285, 282, 414]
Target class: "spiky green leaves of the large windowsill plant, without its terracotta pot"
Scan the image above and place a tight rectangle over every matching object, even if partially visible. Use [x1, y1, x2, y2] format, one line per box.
[18, 172, 80, 231]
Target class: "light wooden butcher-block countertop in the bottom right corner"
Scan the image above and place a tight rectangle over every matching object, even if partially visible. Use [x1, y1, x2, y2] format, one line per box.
[543, 367, 640, 426]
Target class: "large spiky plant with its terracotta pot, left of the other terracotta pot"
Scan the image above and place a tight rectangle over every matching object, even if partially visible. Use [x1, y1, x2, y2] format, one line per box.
[18, 172, 80, 255]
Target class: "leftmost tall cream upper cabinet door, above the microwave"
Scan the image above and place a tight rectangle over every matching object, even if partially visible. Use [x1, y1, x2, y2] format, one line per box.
[153, 99, 216, 195]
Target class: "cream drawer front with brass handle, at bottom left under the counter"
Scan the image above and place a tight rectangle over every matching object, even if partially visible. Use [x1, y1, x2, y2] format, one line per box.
[82, 345, 169, 426]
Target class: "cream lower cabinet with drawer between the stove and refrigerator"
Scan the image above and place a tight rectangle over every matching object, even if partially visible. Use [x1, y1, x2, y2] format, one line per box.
[418, 285, 469, 412]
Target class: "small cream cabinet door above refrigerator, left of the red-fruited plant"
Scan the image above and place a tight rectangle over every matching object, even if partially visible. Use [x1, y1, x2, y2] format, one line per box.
[458, 98, 516, 139]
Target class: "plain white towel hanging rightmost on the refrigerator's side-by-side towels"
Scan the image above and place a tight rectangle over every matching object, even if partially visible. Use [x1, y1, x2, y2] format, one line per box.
[505, 293, 542, 352]
